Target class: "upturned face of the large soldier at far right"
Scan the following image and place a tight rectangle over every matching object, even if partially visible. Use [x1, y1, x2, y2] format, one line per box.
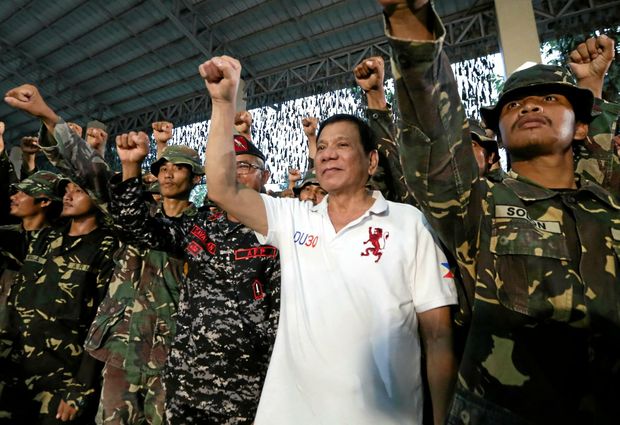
[499, 93, 587, 161]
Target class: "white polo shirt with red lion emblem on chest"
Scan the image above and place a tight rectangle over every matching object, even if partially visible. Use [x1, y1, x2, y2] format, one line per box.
[255, 192, 457, 425]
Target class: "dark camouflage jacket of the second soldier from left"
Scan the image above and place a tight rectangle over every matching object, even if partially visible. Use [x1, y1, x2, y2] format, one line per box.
[0, 227, 117, 407]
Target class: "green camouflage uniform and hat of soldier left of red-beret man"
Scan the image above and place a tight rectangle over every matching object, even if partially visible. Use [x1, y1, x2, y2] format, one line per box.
[40, 121, 203, 424]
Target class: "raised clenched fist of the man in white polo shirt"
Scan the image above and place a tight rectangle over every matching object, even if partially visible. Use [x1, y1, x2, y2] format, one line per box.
[198, 56, 241, 104]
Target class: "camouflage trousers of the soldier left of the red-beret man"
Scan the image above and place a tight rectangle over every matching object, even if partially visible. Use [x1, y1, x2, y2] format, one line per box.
[97, 364, 166, 425]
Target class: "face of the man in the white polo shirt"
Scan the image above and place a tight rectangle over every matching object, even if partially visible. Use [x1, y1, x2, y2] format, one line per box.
[314, 121, 377, 193]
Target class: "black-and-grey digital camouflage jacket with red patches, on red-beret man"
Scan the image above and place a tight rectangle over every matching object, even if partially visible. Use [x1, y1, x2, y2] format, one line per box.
[111, 179, 280, 423]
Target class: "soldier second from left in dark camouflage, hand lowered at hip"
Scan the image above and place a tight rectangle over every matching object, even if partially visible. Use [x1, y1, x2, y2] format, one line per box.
[0, 177, 117, 424]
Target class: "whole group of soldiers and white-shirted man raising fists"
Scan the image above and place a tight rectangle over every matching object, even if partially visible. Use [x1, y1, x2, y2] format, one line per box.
[0, 0, 620, 425]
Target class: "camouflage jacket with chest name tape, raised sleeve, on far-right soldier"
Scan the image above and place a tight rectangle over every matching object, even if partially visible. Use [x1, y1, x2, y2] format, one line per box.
[390, 4, 620, 424]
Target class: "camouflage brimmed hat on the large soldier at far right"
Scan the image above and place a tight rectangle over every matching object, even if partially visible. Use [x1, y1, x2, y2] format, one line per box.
[480, 64, 594, 131]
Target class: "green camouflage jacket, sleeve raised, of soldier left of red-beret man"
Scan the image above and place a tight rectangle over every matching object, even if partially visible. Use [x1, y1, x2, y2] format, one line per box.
[40, 120, 197, 384]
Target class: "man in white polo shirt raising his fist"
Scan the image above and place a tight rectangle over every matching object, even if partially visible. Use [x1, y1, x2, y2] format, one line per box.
[200, 56, 456, 425]
